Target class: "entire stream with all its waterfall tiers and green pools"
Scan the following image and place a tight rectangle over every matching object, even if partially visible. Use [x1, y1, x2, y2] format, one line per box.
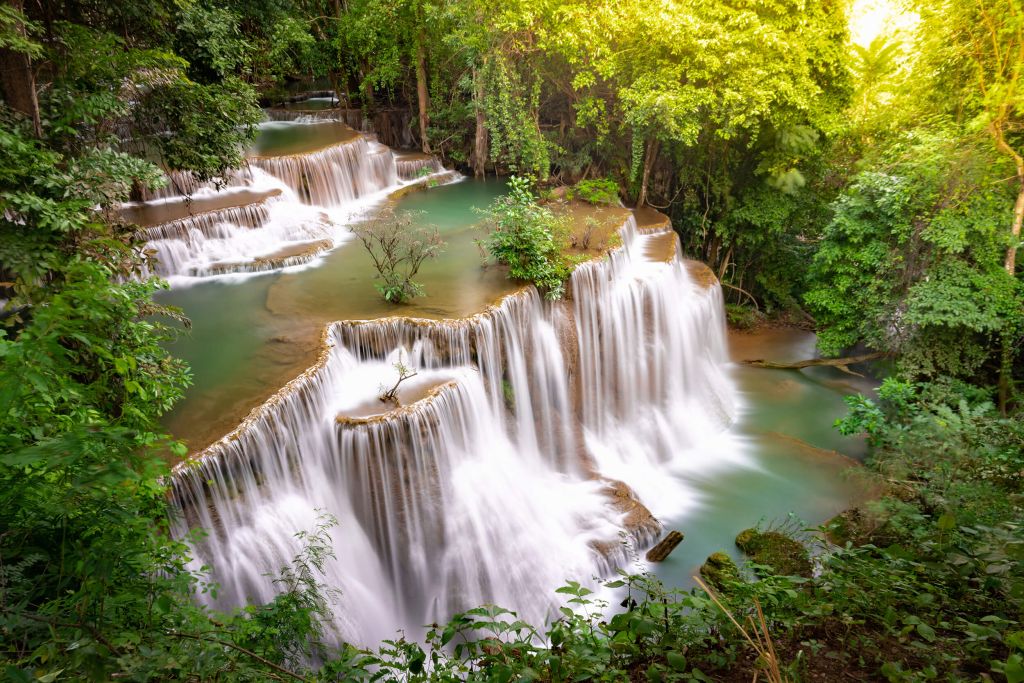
[144, 116, 872, 644]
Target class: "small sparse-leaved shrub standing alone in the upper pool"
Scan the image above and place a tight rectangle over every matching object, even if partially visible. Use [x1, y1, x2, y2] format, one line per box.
[352, 208, 444, 303]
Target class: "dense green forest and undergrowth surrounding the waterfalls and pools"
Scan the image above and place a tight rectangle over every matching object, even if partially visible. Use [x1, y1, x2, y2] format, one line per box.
[0, 0, 1024, 683]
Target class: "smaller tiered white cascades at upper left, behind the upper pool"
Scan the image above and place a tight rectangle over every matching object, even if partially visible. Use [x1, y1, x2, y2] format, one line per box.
[136, 123, 452, 287]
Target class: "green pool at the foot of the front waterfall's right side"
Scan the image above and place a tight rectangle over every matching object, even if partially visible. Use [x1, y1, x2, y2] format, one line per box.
[653, 330, 873, 587]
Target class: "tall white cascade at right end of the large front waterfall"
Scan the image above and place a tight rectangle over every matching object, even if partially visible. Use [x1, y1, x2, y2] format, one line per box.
[571, 221, 734, 516]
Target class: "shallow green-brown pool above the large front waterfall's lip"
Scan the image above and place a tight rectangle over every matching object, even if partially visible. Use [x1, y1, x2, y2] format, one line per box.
[158, 180, 514, 450]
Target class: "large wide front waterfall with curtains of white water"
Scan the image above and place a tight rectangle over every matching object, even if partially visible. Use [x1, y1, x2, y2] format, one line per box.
[172, 218, 732, 643]
